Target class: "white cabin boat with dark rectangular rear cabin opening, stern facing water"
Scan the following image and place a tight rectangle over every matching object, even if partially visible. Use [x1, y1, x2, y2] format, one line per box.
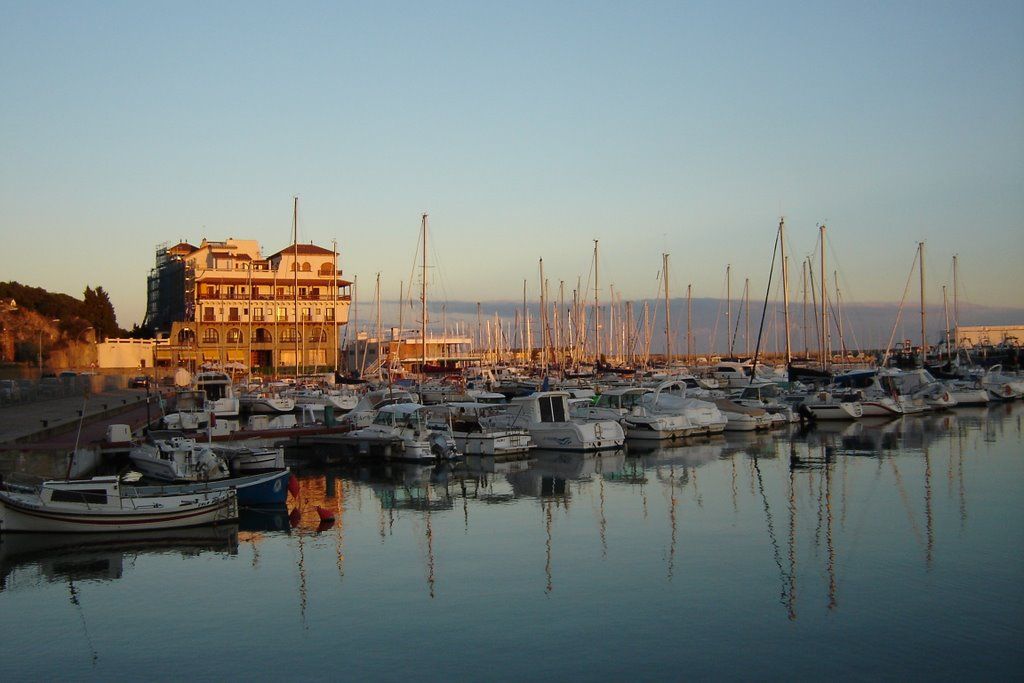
[484, 391, 626, 451]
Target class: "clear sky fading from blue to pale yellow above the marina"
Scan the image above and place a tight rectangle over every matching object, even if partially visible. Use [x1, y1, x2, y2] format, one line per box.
[0, 0, 1024, 326]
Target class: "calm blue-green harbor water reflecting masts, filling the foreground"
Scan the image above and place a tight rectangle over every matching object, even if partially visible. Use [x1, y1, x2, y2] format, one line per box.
[0, 402, 1024, 680]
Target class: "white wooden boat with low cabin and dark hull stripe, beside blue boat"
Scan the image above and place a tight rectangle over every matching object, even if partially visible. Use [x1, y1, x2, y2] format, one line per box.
[0, 476, 239, 532]
